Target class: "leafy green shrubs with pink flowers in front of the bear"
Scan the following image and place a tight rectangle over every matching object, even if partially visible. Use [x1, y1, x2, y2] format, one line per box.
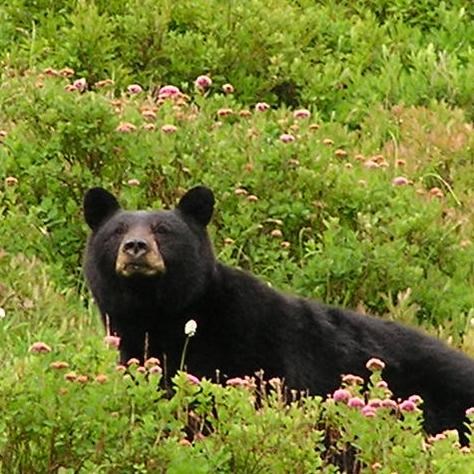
[0, 326, 473, 473]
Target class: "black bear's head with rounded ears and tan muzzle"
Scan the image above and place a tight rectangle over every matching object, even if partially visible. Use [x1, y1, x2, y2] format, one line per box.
[84, 186, 215, 312]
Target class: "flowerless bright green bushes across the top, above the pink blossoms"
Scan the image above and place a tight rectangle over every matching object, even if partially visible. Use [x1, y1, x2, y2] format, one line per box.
[0, 0, 474, 122]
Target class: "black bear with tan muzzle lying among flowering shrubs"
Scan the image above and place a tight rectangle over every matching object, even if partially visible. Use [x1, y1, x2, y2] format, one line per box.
[84, 186, 474, 439]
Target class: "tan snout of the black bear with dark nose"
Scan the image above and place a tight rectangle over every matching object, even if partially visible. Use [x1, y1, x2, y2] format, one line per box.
[115, 232, 165, 277]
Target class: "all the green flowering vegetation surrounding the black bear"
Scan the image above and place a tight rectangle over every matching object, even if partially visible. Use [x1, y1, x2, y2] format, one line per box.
[0, 0, 474, 472]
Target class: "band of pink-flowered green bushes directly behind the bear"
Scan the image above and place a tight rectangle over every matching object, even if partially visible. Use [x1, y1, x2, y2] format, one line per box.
[0, 74, 474, 335]
